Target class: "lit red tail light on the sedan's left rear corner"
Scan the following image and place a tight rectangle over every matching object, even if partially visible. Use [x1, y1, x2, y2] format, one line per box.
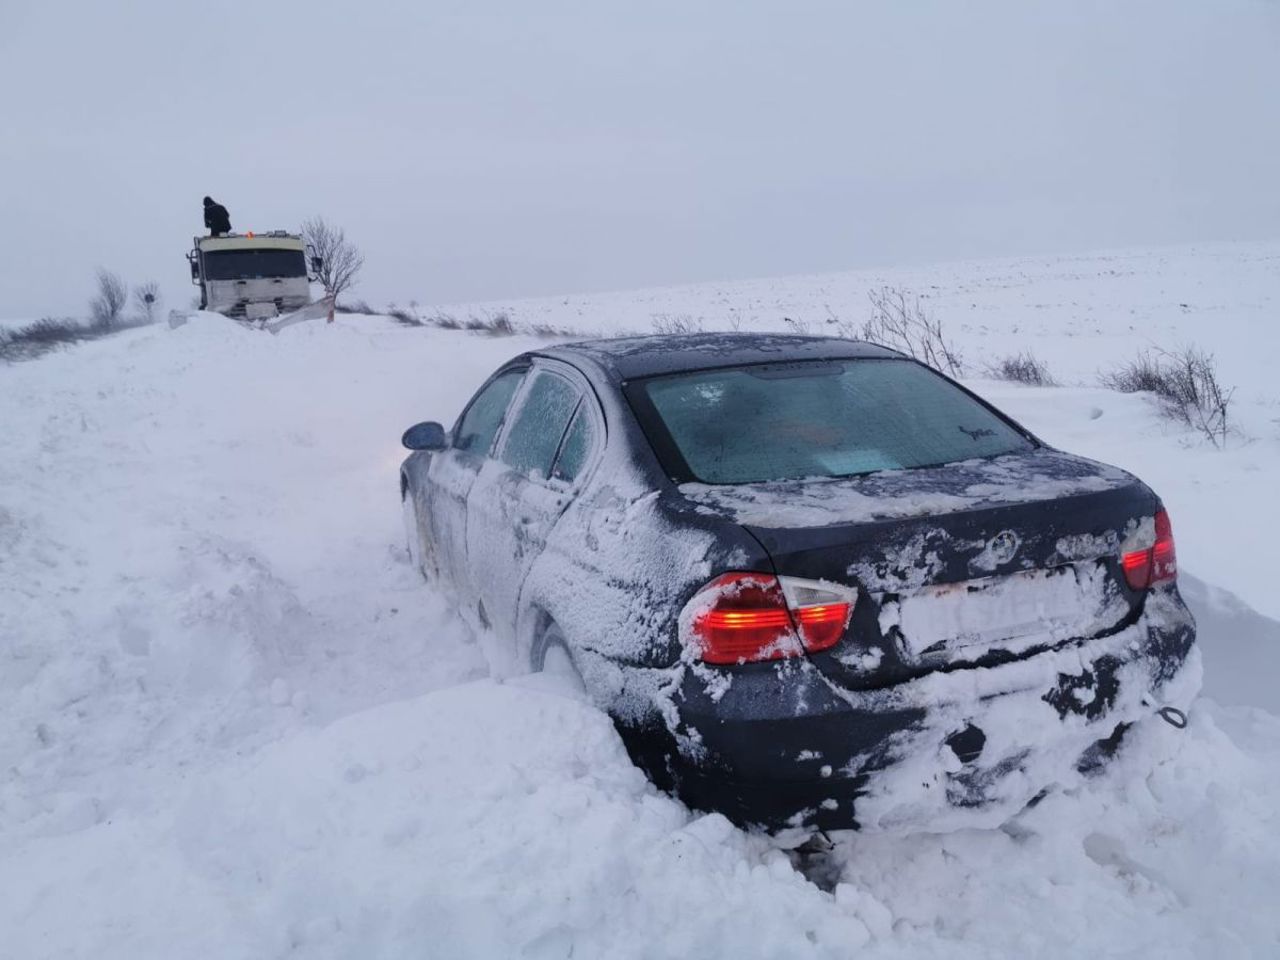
[681, 573, 856, 663]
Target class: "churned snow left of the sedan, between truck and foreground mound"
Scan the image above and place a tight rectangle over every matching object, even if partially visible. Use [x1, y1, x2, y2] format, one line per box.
[0, 321, 511, 836]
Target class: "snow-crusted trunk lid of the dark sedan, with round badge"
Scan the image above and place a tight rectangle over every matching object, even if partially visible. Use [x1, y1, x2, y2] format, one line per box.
[681, 448, 1157, 689]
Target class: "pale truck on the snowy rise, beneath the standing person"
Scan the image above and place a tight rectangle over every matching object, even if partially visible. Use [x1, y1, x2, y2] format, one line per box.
[187, 230, 321, 324]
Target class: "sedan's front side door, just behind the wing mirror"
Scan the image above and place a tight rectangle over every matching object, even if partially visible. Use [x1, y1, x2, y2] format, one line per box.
[419, 366, 527, 594]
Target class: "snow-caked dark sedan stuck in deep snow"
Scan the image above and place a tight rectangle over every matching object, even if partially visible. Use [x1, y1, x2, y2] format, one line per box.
[401, 334, 1199, 828]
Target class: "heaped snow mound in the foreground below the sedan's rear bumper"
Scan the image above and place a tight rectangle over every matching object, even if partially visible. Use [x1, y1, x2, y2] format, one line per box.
[0, 681, 1280, 957]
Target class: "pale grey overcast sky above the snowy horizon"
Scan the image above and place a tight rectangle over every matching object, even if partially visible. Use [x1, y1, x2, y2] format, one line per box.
[0, 0, 1280, 317]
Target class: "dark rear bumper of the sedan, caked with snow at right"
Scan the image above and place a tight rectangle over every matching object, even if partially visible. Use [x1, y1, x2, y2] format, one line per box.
[650, 590, 1201, 829]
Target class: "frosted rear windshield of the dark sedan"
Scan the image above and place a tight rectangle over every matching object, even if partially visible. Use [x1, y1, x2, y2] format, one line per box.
[627, 360, 1034, 484]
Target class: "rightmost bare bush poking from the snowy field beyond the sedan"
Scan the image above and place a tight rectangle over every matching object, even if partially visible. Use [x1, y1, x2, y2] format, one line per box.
[1100, 347, 1235, 447]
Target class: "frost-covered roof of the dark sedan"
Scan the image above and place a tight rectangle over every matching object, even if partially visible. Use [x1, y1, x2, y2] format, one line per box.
[536, 333, 902, 380]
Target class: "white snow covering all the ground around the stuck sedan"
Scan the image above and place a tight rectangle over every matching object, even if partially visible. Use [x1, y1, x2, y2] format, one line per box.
[0, 244, 1280, 960]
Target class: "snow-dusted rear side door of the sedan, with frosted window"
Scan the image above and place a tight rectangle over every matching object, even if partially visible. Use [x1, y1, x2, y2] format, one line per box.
[467, 361, 584, 640]
